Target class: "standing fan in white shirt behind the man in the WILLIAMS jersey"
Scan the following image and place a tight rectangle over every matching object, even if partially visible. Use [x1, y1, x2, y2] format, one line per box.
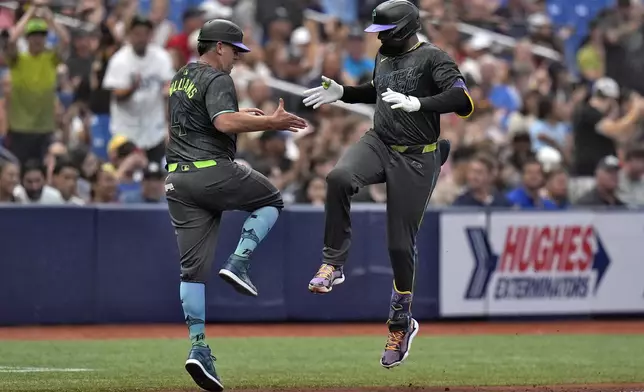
[103, 17, 175, 162]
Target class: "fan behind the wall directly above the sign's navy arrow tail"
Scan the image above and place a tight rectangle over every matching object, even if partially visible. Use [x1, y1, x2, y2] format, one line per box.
[452, 155, 512, 207]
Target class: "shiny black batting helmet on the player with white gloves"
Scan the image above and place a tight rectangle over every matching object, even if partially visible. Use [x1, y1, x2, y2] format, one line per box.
[365, 0, 420, 41]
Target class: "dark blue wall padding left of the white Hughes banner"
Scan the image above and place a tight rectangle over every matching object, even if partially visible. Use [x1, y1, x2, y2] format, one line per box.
[0, 207, 438, 325]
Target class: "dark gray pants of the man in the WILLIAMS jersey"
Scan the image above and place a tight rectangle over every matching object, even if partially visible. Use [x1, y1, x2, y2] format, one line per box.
[165, 159, 284, 283]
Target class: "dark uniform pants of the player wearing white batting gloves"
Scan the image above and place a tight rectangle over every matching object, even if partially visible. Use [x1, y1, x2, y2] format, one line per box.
[323, 130, 441, 292]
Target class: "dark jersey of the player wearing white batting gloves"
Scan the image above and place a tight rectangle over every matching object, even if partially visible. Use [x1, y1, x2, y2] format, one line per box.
[373, 42, 464, 146]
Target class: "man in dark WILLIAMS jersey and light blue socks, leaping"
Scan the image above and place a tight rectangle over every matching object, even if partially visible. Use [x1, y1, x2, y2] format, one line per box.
[165, 19, 306, 391]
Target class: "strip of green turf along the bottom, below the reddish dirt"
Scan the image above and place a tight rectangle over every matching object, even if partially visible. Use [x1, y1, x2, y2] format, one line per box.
[0, 335, 644, 392]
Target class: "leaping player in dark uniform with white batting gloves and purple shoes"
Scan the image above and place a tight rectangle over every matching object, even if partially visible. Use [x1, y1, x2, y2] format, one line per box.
[304, 0, 474, 368]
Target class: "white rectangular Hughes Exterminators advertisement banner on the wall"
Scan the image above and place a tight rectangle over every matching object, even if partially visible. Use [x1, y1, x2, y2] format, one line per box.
[440, 211, 644, 316]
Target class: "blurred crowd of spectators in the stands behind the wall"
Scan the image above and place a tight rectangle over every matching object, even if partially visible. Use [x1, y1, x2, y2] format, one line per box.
[0, 0, 644, 209]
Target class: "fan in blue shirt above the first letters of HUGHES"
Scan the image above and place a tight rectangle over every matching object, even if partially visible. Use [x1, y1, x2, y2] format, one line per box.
[506, 159, 558, 210]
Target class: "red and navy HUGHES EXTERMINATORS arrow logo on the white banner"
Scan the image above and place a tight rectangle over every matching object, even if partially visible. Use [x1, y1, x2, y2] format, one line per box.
[465, 224, 609, 300]
